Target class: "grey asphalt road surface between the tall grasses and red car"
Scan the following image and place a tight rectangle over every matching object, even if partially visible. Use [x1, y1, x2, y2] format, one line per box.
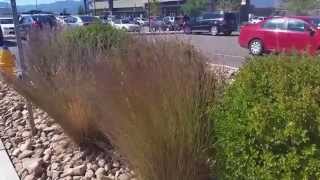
[5, 34, 249, 68]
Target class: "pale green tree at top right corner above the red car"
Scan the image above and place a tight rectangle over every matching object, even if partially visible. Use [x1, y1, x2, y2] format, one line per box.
[282, 0, 320, 15]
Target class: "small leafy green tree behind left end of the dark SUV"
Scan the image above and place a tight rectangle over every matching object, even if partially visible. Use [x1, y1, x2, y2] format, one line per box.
[182, 0, 209, 16]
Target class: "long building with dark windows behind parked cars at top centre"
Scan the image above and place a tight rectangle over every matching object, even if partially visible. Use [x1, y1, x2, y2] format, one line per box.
[88, 0, 185, 17]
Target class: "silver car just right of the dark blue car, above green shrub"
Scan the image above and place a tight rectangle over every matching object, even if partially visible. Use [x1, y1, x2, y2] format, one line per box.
[65, 15, 101, 27]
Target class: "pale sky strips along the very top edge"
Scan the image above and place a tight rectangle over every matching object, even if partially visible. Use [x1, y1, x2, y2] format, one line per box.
[0, 0, 279, 7]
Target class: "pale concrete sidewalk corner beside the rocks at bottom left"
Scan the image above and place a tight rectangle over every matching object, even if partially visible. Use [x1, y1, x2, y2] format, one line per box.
[0, 139, 20, 180]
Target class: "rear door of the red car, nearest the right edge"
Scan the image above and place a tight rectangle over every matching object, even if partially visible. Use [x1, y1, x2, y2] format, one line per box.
[284, 19, 316, 52]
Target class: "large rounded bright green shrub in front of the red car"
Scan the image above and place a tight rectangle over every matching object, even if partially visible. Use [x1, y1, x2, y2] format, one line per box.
[215, 56, 320, 179]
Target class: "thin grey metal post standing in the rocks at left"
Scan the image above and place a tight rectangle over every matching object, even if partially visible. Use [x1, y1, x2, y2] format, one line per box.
[10, 0, 36, 135]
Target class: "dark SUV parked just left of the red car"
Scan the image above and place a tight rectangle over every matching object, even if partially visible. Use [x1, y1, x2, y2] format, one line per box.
[184, 12, 238, 36]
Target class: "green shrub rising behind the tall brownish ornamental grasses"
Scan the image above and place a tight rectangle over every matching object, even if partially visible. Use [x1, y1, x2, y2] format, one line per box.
[64, 23, 128, 50]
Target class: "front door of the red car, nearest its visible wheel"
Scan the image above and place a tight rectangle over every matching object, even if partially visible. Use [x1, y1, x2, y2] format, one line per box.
[261, 18, 287, 52]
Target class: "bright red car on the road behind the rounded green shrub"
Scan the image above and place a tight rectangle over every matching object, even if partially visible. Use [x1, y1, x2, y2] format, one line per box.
[239, 17, 320, 55]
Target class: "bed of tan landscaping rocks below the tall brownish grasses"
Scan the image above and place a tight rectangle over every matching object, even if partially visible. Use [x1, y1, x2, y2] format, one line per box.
[0, 81, 134, 180]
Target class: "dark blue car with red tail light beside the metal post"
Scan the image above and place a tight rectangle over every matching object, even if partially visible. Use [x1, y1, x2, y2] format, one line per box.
[19, 14, 57, 39]
